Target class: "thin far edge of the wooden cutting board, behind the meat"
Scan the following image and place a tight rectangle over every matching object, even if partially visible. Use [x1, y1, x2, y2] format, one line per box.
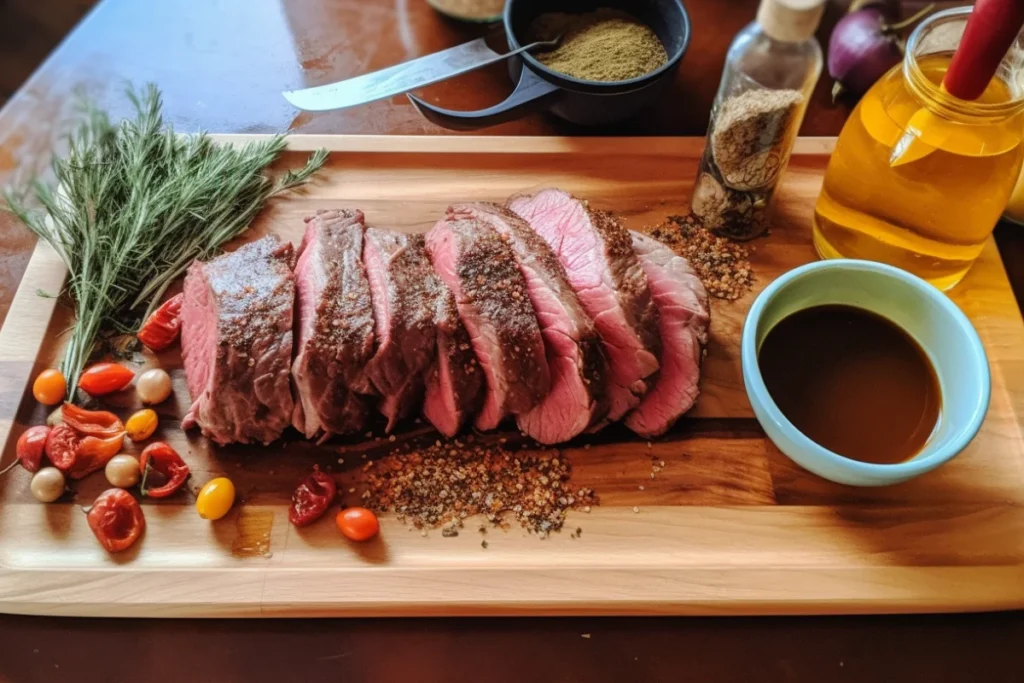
[203, 133, 836, 157]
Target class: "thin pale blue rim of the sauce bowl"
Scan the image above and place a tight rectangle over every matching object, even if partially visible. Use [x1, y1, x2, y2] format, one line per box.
[740, 259, 992, 481]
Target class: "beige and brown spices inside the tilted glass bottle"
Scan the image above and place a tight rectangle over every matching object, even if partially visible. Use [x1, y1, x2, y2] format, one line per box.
[692, 89, 804, 240]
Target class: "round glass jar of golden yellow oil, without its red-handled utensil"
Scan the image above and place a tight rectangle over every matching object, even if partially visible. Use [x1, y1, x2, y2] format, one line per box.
[814, 7, 1024, 289]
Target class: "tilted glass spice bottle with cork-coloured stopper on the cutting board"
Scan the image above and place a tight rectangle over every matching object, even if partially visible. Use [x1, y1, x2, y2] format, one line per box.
[691, 0, 824, 240]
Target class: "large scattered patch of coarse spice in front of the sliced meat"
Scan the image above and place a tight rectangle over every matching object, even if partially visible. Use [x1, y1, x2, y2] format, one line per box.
[364, 441, 598, 547]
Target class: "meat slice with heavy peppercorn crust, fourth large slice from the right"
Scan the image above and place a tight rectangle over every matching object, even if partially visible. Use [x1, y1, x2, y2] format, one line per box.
[426, 216, 551, 430]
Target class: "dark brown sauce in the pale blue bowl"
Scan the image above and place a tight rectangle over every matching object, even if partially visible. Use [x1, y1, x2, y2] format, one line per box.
[758, 305, 942, 464]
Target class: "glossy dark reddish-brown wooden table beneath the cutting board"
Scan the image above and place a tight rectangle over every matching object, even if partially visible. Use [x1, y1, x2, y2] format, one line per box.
[0, 0, 1024, 683]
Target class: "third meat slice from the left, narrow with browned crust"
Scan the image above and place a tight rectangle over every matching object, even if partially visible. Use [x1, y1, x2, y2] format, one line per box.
[362, 227, 437, 432]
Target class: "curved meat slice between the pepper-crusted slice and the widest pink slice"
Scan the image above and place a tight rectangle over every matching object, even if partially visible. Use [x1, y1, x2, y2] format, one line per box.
[449, 204, 608, 443]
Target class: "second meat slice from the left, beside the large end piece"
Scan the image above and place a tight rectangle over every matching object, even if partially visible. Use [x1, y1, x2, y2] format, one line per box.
[292, 211, 374, 438]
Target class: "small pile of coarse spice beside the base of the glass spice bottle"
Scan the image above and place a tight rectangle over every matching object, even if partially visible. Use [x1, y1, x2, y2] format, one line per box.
[650, 215, 754, 301]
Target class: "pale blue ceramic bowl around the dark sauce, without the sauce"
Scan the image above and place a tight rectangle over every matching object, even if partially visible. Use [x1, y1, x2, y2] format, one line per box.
[740, 259, 991, 486]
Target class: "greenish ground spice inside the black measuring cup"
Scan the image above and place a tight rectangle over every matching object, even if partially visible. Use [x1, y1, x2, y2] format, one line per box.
[529, 7, 669, 83]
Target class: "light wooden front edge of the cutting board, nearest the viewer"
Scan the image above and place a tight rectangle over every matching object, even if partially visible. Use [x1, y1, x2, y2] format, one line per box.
[0, 565, 1024, 618]
